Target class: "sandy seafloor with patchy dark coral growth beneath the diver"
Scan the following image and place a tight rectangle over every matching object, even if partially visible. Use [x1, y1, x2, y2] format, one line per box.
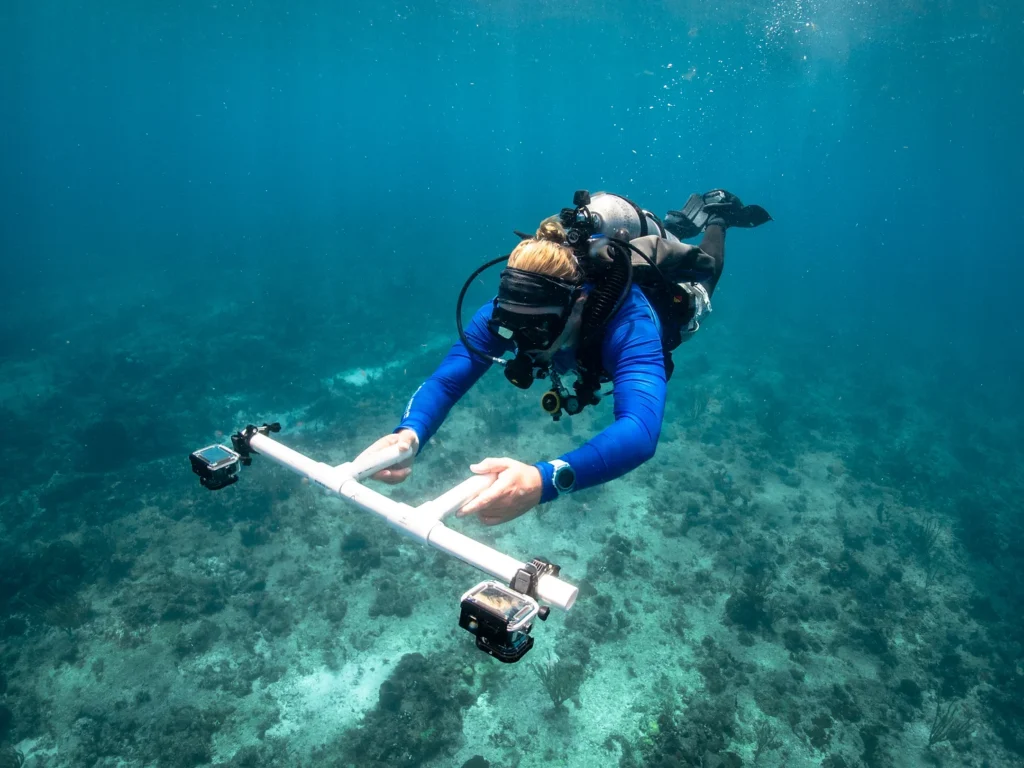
[0, 284, 1024, 768]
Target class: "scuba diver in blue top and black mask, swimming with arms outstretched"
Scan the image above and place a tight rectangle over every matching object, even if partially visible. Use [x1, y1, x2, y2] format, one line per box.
[364, 189, 771, 525]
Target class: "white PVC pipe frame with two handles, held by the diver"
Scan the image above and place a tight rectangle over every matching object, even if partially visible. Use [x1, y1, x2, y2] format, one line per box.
[243, 433, 580, 610]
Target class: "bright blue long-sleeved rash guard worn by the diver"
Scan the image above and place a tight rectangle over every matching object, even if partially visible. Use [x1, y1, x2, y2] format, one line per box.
[396, 286, 666, 503]
